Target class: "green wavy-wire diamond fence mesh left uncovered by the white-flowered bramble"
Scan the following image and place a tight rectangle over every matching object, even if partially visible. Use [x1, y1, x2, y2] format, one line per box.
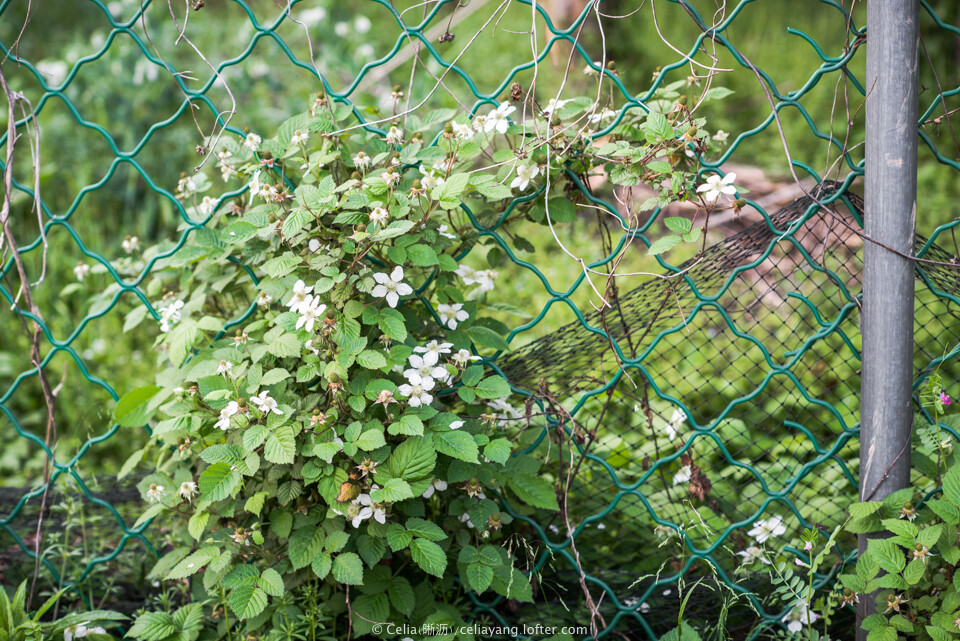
[0, 0, 960, 638]
